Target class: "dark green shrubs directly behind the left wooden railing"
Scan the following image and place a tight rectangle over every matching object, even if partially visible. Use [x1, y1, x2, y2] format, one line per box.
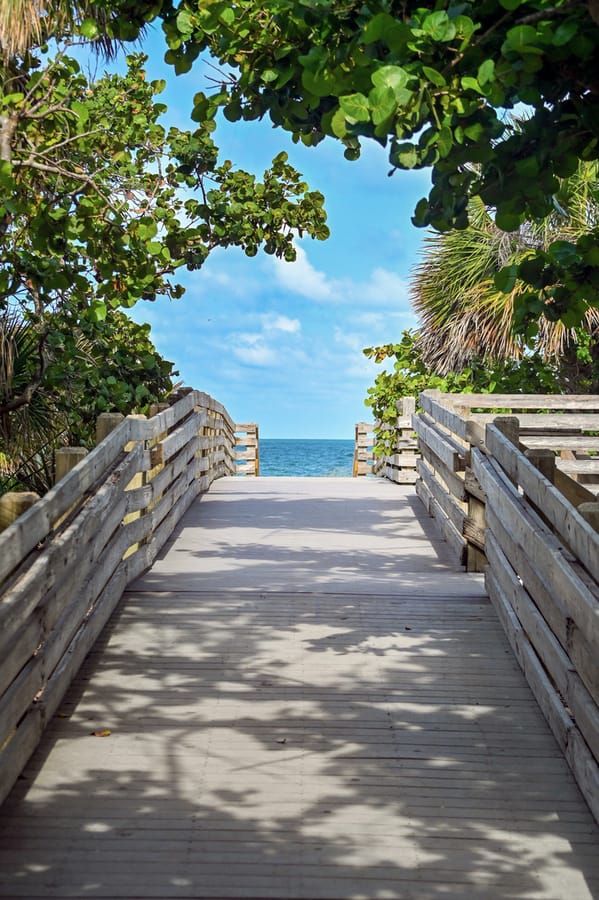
[0, 309, 177, 493]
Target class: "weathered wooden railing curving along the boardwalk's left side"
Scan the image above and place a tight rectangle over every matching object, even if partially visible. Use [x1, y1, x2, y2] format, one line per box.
[0, 391, 235, 802]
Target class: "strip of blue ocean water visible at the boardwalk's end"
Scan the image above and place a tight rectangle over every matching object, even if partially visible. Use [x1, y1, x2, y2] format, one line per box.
[260, 438, 354, 478]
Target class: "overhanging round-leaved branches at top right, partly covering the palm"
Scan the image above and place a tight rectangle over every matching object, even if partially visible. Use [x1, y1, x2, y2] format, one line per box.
[162, 0, 599, 326]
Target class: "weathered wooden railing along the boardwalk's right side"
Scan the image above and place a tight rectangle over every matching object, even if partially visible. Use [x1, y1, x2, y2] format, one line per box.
[414, 391, 599, 820]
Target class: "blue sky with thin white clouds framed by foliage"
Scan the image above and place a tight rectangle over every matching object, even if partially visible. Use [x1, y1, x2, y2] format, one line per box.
[116, 33, 429, 438]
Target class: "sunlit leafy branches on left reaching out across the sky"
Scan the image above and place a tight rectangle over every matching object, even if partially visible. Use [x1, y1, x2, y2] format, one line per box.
[0, 49, 328, 318]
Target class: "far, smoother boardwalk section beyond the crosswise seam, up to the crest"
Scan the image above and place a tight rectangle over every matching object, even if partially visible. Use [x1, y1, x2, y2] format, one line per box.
[134, 479, 483, 595]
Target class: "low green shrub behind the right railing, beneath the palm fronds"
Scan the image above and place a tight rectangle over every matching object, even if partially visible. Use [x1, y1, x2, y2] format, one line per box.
[364, 331, 567, 456]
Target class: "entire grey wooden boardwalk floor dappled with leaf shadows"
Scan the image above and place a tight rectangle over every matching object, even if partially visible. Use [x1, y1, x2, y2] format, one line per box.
[0, 478, 599, 900]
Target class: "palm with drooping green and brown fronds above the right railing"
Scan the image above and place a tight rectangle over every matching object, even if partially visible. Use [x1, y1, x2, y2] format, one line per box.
[411, 163, 599, 374]
